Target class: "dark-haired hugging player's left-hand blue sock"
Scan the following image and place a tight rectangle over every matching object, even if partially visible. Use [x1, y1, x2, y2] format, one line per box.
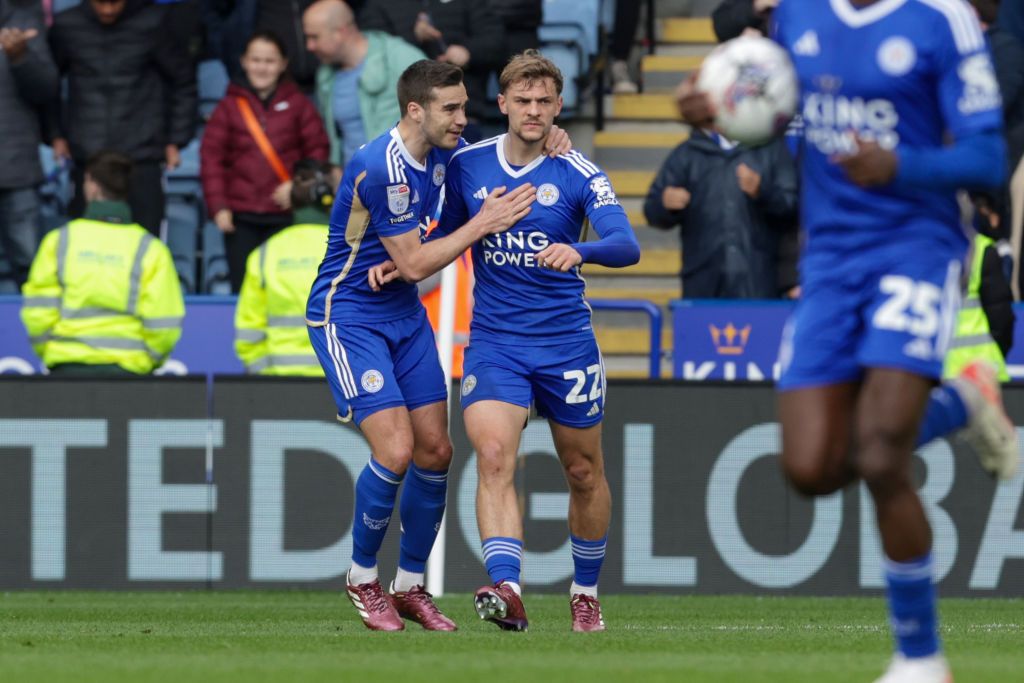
[352, 458, 401, 567]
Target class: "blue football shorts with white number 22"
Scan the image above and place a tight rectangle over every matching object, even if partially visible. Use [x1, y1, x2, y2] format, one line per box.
[462, 336, 607, 429]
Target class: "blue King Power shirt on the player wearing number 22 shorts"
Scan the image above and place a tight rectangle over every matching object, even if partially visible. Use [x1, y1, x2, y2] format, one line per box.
[438, 135, 628, 345]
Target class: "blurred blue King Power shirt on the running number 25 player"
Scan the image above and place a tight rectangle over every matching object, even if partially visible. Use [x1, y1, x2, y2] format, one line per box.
[773, 0, 1001, 275]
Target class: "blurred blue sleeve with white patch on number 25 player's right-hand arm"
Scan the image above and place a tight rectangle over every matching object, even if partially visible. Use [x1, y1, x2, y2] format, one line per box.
[935, 9, 1002, 138]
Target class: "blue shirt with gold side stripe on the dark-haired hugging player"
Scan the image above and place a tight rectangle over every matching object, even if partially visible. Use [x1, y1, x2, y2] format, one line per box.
[306, 128, 465, 324]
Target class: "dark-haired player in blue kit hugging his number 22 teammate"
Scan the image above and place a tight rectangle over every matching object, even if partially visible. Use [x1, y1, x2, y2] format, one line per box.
[306, 60, 570, 631]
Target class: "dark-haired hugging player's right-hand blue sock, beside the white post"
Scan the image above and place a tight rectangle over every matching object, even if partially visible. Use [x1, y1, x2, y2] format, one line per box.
[398, 464, 447, 573]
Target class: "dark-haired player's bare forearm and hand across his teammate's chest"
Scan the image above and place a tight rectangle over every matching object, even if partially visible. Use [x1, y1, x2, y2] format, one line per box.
[381, 183, 537, 283]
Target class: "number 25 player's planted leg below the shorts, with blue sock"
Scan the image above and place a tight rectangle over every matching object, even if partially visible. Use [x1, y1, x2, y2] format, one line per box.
[856, 369, 946, 680]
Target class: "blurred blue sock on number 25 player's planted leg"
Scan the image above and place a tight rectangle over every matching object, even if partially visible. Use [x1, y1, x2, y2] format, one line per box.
[886, 553, 939, 657]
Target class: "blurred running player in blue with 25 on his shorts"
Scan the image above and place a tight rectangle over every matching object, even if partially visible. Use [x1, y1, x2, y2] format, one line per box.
[773, 0, 1019, 683]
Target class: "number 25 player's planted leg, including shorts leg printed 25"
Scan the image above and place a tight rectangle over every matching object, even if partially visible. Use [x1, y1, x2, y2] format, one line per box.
[855, 259, 959, 683]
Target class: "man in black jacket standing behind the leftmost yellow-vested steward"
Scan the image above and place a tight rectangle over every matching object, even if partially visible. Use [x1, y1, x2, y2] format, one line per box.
[50, 0, 197, 234]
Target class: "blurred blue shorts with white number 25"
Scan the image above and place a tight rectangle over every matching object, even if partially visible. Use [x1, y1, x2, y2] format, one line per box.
[778, 253, 962, 390]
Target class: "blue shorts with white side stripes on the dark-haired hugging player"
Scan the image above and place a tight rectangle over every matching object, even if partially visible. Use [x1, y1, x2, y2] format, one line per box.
[308, 308, 447, 424]
